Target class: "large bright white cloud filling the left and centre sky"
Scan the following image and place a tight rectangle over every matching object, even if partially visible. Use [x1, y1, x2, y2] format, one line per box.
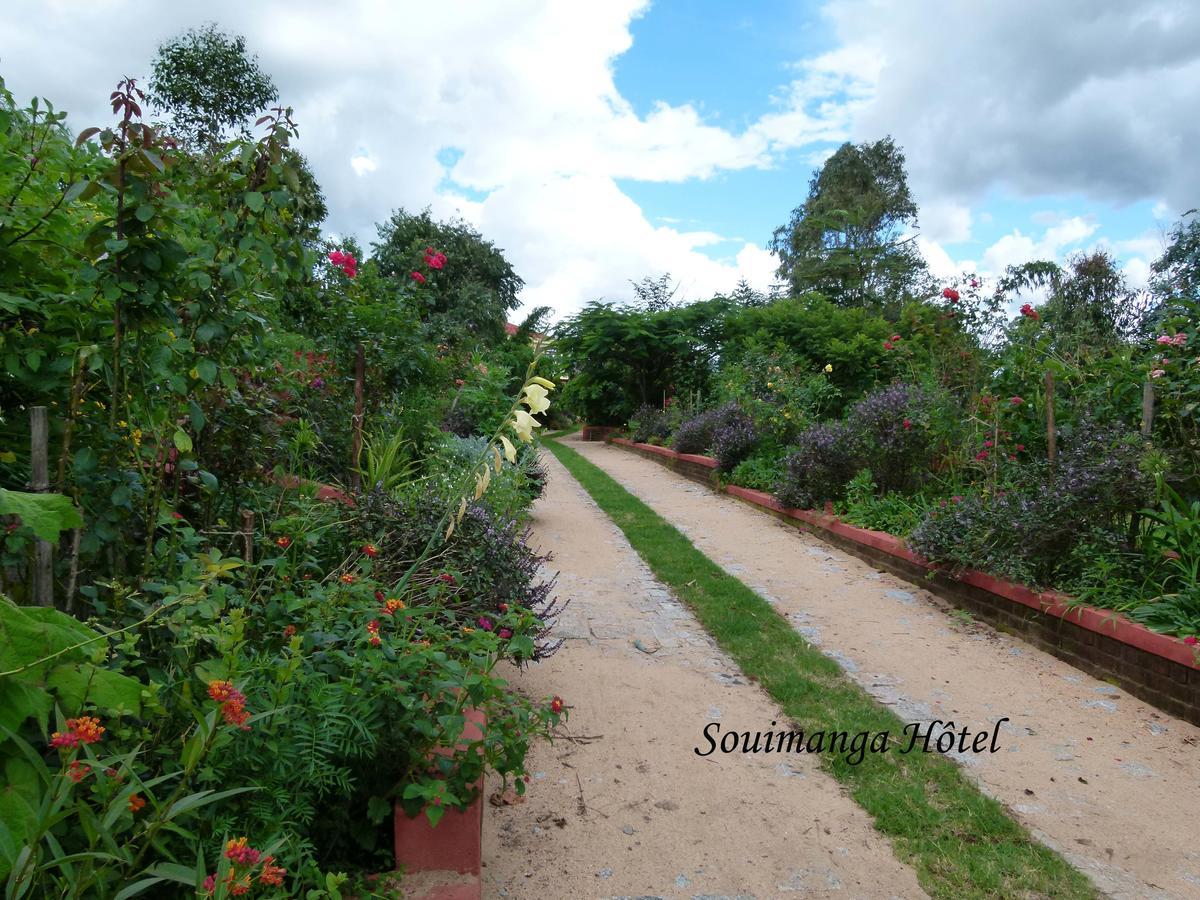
[0, 0, 871, 313]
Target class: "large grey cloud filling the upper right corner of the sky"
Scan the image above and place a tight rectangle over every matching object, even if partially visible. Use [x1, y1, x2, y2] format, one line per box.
[787, 0, 1200, 209]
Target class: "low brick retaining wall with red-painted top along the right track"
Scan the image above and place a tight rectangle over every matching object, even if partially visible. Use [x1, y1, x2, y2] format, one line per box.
[611, 438, 1200, 725]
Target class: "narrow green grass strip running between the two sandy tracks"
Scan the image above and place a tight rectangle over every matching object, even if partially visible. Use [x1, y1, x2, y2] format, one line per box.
[546, 440, 1097, 899]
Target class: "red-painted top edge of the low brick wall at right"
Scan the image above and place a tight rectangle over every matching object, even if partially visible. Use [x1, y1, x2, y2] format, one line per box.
[612, 438, 1200, 670]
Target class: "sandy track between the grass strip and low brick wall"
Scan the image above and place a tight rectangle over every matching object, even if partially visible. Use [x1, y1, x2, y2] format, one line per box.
[565, 440, 1200, 898]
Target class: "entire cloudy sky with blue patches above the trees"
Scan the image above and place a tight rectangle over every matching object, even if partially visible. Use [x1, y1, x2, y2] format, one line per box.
[0, 0, 1200, 314]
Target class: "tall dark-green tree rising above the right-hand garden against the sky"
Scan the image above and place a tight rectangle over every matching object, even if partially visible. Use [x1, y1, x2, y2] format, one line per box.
[770, 137, 928, 313]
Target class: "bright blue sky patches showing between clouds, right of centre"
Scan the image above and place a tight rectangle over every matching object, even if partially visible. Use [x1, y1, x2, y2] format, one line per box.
[613, 0, 1172, 282]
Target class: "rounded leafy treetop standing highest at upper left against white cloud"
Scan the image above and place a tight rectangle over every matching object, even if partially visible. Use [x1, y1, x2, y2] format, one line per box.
[150, 23, 280, 150]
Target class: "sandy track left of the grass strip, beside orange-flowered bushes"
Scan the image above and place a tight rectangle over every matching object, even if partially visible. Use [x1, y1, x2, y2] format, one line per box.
[482, 454, 925, 900]
